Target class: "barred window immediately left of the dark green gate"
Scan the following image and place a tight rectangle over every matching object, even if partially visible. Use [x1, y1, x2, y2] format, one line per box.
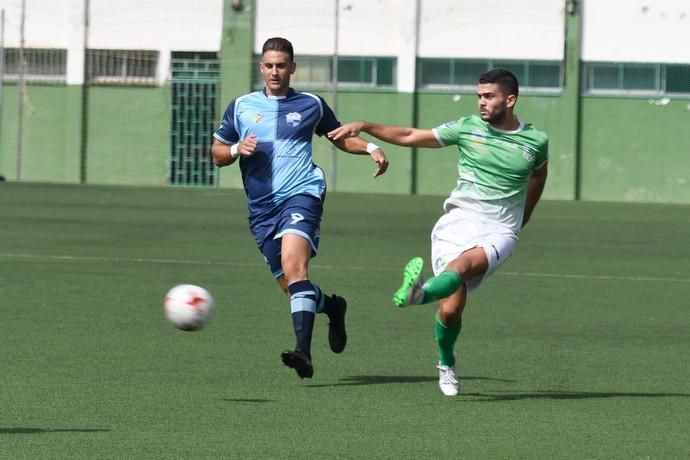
[86, 49, 158, 85]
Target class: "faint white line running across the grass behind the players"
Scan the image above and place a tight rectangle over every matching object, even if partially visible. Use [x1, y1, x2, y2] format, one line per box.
[0, 253, 690, 283]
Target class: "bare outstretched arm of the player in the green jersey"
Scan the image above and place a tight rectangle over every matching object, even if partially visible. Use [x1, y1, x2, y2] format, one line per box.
[328, 121, 441, 148]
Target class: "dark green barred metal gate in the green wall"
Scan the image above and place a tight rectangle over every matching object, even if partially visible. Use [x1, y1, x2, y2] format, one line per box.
[169, 52, 220, 186]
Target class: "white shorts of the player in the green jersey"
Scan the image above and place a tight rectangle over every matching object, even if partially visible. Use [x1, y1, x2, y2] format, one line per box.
[431, 208, 518, 292]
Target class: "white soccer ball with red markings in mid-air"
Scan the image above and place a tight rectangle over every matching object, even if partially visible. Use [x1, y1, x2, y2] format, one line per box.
[163, 284, 214, 331]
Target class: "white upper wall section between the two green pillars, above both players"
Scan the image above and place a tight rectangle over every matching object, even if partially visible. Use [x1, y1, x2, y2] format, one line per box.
[254, 0, 565, 91]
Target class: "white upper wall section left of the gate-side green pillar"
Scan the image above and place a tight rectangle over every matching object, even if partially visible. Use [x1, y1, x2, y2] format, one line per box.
[0, 0, 223, 84]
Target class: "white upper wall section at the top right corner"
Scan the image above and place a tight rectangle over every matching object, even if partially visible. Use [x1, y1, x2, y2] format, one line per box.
[582, 0, 690, 64]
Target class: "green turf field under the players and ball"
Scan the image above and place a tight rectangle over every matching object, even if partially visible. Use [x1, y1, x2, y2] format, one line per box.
[0, 183, 690, 459]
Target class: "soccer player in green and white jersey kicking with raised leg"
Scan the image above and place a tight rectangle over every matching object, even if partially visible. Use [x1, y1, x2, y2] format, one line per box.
[329, 69, 548, 396]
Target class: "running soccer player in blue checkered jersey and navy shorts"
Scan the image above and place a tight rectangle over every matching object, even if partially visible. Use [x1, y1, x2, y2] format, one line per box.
[212, 37, 388, 378]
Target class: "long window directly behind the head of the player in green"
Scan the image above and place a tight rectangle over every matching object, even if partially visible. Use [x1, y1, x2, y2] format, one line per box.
[417, 58, 563, 93]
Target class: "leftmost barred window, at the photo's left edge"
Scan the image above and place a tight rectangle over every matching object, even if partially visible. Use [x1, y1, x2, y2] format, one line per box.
[3, 48, 67, 83]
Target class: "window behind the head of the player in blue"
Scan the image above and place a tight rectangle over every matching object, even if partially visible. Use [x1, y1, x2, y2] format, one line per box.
[254, 55, 396, 89]
